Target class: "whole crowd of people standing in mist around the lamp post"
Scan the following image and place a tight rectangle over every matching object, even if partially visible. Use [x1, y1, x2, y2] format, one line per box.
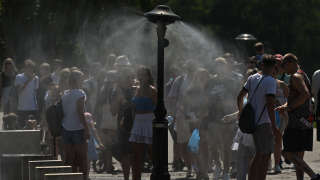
[0, 43, 320, 180]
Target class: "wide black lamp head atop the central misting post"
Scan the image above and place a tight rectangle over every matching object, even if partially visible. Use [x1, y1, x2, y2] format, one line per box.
[144, 5, 181, 25]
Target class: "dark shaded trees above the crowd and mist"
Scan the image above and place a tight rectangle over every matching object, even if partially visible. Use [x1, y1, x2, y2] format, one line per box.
[0, 0, 320, 75]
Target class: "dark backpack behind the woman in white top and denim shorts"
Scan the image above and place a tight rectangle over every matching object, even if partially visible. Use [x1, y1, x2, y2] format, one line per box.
[46, 101, 63, 137]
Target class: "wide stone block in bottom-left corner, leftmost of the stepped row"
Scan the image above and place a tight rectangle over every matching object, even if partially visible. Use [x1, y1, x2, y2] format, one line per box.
[1, 154, 53, 180]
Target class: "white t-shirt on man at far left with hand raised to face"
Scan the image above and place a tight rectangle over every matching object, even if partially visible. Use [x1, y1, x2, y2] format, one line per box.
[14, 73, 39, 111]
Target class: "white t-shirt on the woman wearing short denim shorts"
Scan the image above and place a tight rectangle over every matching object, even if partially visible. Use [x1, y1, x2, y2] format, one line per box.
[61, 89, 86, 131]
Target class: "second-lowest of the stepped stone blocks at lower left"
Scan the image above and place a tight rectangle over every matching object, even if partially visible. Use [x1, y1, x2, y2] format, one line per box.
[34, 166, 72, 180]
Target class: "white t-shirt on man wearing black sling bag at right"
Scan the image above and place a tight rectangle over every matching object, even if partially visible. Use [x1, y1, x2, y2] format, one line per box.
[244, 73, 277, 125]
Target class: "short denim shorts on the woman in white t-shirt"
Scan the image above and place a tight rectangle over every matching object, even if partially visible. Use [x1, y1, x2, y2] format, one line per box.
[62, 129, 86, 144]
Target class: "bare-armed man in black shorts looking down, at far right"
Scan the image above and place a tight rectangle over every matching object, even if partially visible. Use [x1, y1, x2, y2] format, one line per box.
[276, 53, 320, 180]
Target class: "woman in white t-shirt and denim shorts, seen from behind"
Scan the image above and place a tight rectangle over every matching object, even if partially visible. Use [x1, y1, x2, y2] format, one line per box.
[61, 70, 89, 180]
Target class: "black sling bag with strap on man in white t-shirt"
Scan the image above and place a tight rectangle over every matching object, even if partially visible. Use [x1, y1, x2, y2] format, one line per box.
[239, 76, 266, 134]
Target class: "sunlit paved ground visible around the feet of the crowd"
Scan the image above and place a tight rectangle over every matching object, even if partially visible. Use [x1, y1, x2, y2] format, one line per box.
[90, 131, 320, 180]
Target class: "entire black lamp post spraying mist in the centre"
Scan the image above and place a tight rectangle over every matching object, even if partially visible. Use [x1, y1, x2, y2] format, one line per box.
[144, 5, 181, 180]
